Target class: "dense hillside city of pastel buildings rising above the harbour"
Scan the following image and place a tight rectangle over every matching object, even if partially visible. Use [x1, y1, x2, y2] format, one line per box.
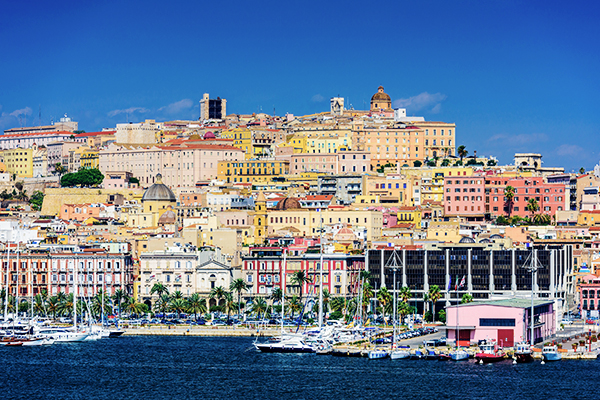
[0, 86, 600, 334]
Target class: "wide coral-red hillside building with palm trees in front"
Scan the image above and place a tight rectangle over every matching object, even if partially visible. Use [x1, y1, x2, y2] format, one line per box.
[485, 175, 569, 217]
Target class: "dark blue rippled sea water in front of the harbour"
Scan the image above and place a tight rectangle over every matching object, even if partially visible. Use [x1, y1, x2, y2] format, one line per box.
[0, 336, 600, 400]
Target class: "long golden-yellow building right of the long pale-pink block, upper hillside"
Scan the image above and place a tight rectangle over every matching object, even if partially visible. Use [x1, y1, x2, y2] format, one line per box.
[217, 159, 290, 183]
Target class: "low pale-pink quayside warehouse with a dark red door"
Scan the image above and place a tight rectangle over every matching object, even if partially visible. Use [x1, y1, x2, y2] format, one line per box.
[446, 298, 556, 347]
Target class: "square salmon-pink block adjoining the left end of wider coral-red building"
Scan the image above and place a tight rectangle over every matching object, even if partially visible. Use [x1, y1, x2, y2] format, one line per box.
[444, 175, 485, 221]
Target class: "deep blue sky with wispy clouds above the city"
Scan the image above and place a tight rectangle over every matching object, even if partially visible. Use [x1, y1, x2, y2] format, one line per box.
[0, 0, 600, 170]
